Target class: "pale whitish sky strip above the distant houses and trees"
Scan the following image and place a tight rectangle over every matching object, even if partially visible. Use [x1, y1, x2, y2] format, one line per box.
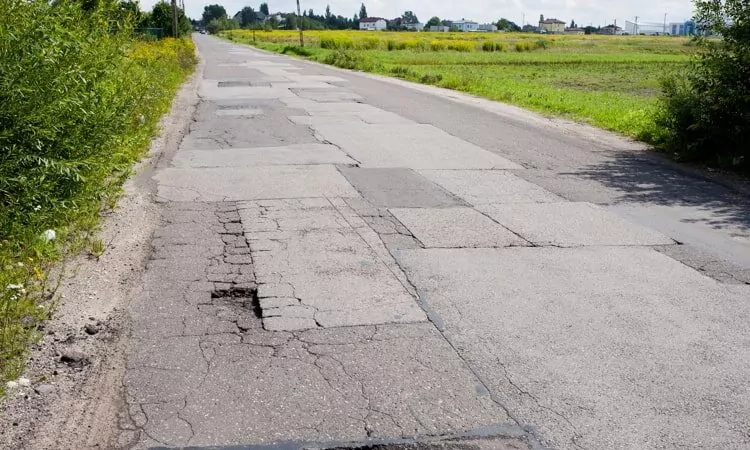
[140, 0, 693, 26]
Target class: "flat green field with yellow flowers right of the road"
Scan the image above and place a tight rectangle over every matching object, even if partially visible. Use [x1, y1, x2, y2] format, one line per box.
[224, 30, 695, 141]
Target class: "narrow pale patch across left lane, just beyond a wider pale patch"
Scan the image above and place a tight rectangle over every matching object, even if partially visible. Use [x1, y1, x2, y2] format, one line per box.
[172, 144, 357, 168]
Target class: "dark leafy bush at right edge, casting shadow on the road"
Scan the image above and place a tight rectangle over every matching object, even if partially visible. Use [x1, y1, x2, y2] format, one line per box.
[656, 0, 750, 171]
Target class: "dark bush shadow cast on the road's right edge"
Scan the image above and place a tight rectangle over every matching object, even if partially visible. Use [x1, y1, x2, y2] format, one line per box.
[569, 153, 750, 231]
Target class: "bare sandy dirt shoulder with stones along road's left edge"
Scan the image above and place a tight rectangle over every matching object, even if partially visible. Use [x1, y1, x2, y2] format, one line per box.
[0, 51, 203, 449]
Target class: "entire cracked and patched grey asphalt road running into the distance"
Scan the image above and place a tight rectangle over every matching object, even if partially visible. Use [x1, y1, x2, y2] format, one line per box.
[119, 36, 750, 449]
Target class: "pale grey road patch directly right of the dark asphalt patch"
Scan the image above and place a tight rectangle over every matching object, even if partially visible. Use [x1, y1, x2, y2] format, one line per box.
[419, 170, 563, 205]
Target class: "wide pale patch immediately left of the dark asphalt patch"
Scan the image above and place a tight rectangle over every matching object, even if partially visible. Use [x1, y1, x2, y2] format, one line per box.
[154, 165, 359, 201]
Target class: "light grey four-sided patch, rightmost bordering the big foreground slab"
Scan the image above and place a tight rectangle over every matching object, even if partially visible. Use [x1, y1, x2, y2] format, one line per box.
[477, 202, 674, 247]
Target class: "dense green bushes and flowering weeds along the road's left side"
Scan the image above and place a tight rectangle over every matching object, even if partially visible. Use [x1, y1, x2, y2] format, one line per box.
[0, 0, 196, 396]
